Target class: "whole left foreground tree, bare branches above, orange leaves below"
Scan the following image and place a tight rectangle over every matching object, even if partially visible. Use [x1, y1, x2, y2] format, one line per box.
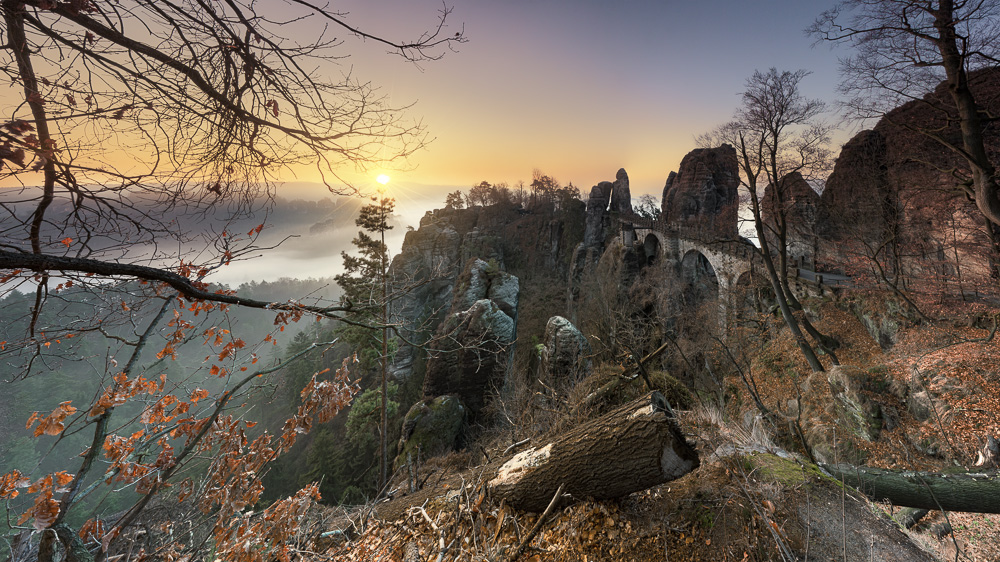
[0, 0, 464, 560]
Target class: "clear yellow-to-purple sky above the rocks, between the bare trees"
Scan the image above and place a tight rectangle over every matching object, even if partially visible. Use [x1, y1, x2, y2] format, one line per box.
[304, 0, 847, 218]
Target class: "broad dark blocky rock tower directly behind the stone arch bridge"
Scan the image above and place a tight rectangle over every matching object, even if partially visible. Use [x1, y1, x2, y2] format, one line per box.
[662, 144, 740, 238]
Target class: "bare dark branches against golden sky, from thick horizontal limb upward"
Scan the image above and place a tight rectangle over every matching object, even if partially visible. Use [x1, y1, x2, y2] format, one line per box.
[0, 0, 464, 316]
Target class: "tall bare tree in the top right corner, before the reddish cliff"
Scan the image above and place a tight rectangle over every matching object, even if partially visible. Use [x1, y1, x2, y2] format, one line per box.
[808, 0, 1000, 269]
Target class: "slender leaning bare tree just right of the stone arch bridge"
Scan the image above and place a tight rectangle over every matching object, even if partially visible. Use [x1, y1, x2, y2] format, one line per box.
[699, 68, 835, 371]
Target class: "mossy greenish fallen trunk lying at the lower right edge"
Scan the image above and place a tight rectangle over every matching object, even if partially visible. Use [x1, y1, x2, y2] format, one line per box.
[819, 463, 1000, 513]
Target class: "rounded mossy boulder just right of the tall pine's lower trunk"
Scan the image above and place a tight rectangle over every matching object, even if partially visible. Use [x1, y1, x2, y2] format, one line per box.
[396, 395, 466, 467]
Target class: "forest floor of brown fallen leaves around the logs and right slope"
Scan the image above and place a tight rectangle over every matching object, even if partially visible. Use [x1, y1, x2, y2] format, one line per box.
[292, 296, 1000, 562]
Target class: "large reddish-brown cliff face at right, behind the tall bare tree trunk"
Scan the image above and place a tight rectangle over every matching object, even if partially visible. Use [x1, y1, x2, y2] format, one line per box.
[816, 69, 1000, 291]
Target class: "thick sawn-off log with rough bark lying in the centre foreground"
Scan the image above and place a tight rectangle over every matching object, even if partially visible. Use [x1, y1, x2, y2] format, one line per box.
[488, 392, 698, 512]
